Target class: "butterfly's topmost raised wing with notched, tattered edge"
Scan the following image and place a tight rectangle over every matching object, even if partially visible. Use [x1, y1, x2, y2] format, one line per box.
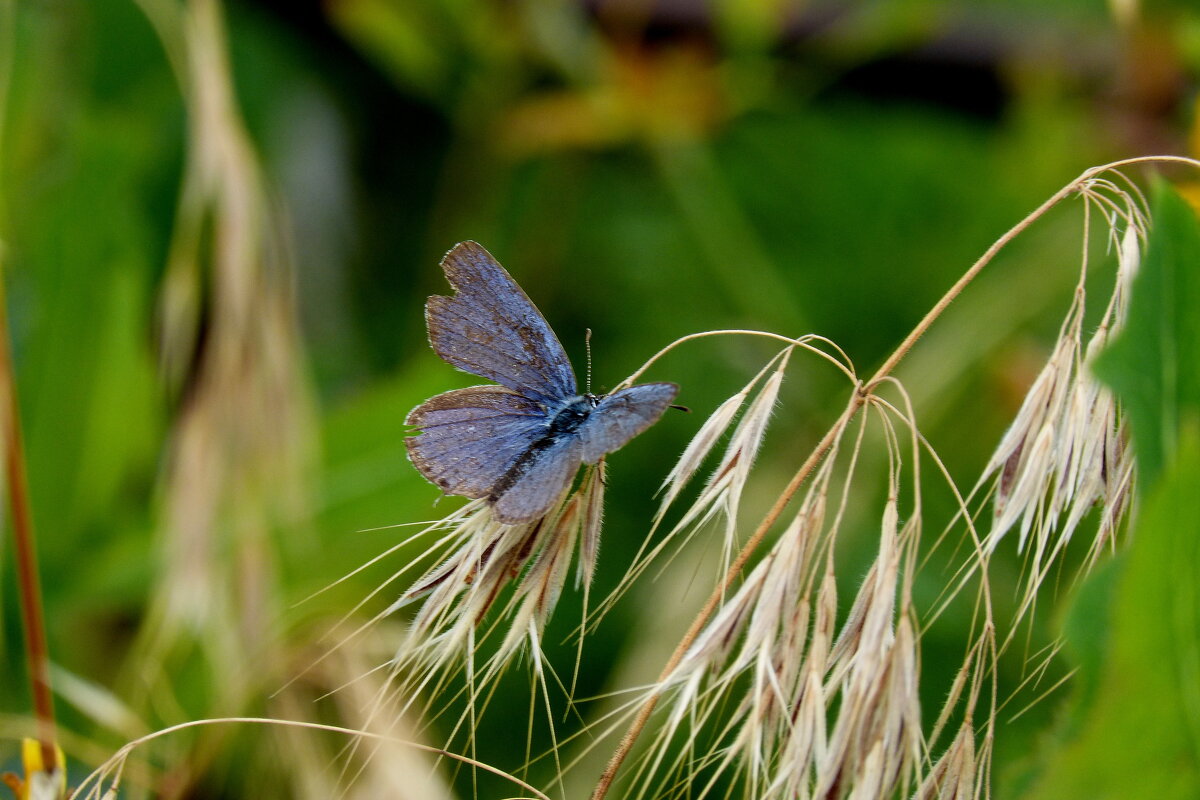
[425, 241, 576, 404]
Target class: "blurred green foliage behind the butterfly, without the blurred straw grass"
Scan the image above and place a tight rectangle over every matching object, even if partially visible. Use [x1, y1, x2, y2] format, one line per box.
[0, 0, 1200, 796]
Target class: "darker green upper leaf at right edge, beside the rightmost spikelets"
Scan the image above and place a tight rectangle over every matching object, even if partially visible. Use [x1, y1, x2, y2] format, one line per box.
[1096, 184, 1200, 489]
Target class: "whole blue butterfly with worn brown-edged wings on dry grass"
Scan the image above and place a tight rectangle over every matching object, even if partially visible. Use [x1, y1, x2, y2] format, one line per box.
[406, 241, 679, 524]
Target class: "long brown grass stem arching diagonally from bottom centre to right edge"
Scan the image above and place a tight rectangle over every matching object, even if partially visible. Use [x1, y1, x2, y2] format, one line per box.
[592, 156, 1200, 800]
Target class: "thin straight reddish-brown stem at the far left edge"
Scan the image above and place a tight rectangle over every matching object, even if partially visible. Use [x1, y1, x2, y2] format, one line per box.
[0, 262, 59, 772]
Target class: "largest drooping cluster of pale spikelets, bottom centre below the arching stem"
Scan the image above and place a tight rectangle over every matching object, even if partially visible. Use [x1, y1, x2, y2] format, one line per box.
[609, 393, 924, 798]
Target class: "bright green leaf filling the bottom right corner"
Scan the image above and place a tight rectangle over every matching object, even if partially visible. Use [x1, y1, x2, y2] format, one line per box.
[1027, 429, 1200, 800]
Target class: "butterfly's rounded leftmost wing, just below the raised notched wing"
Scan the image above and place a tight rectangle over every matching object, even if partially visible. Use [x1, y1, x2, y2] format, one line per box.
[406, 386, 546, 498]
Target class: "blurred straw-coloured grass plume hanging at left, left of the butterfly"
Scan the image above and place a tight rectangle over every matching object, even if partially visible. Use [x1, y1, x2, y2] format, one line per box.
[97, 0, 316, 792]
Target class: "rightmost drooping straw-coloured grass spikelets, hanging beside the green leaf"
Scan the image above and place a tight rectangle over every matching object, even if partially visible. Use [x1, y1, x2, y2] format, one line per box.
[980, 179, 1147, 613]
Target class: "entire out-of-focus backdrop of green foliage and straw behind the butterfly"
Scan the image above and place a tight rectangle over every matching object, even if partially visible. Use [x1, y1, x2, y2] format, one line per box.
[0, 0, 1200, 798]
